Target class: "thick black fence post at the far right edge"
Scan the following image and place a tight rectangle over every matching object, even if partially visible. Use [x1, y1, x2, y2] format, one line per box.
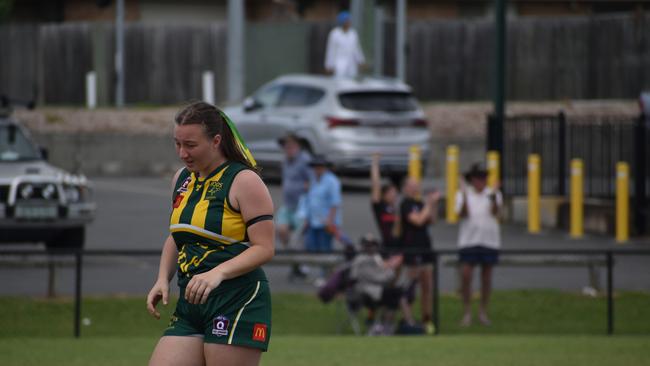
[634, 113, 650, 235]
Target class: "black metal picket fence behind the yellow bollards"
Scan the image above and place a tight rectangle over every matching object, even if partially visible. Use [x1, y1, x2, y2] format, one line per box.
[488, 112, 650, 233]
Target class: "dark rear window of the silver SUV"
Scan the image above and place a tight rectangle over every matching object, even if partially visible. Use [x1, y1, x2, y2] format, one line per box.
[339, 91, 418, 112]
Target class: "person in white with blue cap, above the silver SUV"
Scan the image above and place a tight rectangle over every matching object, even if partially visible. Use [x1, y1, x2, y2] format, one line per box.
[325, 11, 365, 78]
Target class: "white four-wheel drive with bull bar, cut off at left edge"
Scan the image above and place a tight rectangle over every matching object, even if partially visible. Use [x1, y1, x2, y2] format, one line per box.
[0, 106, 95, 249]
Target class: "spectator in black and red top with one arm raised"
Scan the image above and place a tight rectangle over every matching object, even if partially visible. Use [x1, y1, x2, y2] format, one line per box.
[370, 154, 399, 252]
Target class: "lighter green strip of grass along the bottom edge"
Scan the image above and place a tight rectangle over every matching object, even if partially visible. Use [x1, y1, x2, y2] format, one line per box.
[0, 335, 650, 366]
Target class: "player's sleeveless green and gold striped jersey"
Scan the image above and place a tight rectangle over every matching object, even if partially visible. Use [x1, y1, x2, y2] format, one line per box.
[169, 162, 266, 292]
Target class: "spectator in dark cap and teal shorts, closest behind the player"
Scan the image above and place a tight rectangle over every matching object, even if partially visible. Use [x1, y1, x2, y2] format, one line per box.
[276, 133, 311, 278]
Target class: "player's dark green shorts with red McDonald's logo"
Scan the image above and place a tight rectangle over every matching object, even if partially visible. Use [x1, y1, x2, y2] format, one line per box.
[163, 281, 271, 351]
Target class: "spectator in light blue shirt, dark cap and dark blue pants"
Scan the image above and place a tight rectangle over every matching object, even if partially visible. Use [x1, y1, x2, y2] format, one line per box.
[304, 155, 341, 252]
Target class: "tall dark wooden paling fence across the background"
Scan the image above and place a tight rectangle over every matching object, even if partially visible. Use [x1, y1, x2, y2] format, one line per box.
[0, 13, 650, 104]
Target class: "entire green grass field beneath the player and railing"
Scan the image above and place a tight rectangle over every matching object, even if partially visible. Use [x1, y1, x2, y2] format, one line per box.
[0, 290, 650, 366]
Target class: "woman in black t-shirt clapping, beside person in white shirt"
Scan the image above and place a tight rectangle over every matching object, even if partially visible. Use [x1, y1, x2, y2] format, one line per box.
[400, 178, 440, 334]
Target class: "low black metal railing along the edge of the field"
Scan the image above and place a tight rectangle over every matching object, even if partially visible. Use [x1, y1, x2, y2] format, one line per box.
[0, 249, 650, 338]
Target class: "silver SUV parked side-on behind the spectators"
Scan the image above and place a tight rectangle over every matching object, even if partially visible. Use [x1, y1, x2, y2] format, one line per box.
[225, 75, 431, 175]
